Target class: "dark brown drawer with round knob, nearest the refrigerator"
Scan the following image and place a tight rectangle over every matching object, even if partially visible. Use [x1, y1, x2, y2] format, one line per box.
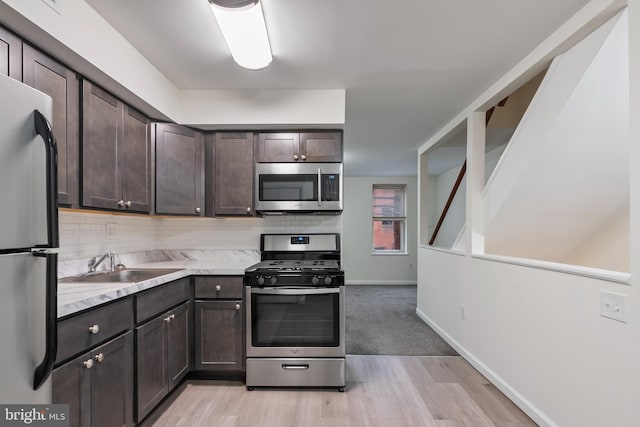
[56, 298, 133, 362]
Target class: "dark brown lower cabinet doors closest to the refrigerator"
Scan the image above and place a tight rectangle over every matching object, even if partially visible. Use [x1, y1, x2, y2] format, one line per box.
[52, 332, 134, 427]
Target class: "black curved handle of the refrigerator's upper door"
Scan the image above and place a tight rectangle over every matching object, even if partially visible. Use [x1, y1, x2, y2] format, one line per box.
[33, 110, 60, 248]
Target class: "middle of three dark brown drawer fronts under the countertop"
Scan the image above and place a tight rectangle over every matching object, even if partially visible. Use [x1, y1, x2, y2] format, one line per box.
[136, 278, 190, 323]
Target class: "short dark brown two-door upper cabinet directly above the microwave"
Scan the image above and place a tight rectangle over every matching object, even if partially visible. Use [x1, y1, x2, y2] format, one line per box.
[258, 131, 342, 162]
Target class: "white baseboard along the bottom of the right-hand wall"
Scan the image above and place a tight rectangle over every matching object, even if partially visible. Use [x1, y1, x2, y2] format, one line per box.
[416, 308, 558, 427]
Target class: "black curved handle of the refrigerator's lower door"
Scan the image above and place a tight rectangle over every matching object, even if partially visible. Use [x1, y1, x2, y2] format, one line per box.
[33, 252, 58, 390]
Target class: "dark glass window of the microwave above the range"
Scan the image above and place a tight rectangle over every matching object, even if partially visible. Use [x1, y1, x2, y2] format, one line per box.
[259, 174, 318, 202]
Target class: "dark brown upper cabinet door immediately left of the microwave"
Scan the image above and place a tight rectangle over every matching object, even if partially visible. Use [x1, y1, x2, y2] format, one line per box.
[215, 132, 255, 215]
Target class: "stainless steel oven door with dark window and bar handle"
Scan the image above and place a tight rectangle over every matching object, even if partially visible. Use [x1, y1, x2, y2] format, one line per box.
[246, 286, 345, 357]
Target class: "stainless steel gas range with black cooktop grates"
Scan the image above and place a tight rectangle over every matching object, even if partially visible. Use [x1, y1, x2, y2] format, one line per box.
[244, 234, 345, 391]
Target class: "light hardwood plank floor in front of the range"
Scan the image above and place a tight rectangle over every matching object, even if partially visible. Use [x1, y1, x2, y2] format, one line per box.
[153, 356, 536, 427]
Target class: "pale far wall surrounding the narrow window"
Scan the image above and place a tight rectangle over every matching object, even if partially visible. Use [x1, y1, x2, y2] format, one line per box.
[342, 177, 417, 285]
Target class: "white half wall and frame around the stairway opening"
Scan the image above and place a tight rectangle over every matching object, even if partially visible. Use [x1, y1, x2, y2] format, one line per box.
[418, 0, 640, 427]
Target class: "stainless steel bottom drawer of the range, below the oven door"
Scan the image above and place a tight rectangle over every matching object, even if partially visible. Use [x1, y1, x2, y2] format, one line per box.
[247, 358, 346, 387]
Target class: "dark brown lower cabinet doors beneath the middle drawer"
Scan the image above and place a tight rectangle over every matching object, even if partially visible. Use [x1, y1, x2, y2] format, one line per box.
[136, 302, 190, 422]
